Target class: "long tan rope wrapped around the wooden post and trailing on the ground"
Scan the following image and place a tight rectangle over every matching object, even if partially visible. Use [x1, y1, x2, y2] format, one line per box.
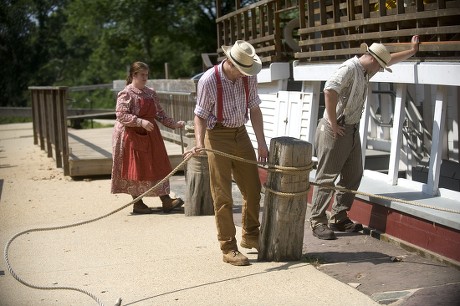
[3, 149, 460, 306]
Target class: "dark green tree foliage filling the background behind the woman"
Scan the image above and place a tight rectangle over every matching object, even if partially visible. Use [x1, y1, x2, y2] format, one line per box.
[0, 0, 262, 106]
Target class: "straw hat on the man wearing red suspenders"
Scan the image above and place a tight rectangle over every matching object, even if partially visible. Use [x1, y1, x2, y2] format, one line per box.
[222, 40, 262, 75]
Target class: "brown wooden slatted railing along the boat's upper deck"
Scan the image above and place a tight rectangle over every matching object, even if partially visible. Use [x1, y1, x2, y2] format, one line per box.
[216, 0, 460, 66]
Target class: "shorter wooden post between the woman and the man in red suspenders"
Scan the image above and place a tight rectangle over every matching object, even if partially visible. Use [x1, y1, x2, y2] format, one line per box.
[184, 122, 214, 216]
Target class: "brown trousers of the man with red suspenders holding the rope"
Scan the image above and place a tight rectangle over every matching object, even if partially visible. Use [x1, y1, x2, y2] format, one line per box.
[205, 124, 261, 253]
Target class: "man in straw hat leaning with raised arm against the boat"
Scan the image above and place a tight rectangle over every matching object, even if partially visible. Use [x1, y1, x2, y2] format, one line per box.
[310, 35, 419, 240]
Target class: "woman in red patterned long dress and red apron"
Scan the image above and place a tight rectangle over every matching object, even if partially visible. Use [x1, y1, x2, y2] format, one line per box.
[112, 62, 185, 214]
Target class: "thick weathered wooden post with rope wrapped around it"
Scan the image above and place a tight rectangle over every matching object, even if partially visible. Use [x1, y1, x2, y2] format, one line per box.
[258, 137, 312, 261]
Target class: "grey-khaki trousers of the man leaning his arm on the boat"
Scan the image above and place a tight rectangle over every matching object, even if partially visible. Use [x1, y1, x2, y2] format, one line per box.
[310, 118, 363, 228]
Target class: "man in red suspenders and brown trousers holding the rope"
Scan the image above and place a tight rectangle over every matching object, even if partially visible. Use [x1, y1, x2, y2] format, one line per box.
[185, 40, 268, 266]
